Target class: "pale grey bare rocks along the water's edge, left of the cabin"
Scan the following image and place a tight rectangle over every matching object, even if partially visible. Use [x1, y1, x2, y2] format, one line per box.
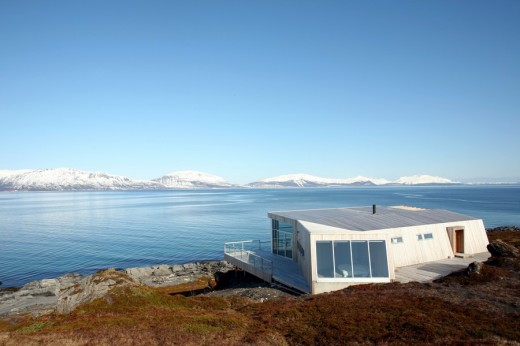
[0, 261, 240, 316]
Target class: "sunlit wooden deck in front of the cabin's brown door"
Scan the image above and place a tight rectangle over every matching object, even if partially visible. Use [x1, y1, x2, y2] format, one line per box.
[395, 252, 491, 283]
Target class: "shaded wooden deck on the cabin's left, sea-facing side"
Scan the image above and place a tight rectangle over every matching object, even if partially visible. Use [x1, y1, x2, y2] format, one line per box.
[224, 249, 311, 293]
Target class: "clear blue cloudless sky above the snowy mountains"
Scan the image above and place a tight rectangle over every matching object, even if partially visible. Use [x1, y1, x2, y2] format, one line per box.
[0, 0, 520, 183]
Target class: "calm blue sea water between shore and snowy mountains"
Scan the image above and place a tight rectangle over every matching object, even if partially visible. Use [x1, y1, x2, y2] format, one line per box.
[0, 186, 520, 287]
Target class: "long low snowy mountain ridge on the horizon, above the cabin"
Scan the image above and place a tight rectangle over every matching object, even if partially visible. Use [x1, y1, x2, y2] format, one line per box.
[247, 174, 454, 188]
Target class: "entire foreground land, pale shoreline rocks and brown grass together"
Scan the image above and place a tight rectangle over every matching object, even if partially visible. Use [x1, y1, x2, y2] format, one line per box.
[0, 230, 520, 345]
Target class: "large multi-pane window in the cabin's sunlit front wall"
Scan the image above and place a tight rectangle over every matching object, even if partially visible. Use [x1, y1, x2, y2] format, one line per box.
[316, 240, 389, 279]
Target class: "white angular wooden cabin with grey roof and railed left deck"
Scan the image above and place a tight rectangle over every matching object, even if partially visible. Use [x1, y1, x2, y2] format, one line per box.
[225, 205, 488, 294]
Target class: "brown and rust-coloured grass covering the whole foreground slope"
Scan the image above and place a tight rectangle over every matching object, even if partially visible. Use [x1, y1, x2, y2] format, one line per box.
[0, 232, 520, 345]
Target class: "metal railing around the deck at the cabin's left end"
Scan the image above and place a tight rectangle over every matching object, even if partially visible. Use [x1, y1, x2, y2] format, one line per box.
[224, 240, 273, 275]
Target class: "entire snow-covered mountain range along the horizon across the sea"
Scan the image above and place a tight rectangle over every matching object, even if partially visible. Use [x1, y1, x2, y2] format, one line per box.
[0, 168, 508, 191]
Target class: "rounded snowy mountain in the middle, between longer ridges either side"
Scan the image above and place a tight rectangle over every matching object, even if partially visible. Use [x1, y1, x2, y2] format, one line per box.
[152, 171, 235, 189]
